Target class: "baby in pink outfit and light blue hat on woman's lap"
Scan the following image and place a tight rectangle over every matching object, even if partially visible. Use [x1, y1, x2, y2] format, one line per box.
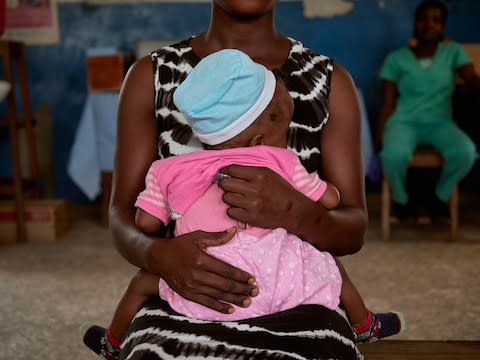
[84, 49, 404, 359]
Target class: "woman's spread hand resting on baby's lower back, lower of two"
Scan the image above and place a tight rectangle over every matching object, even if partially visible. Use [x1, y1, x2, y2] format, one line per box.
[151, 228, 258, 313]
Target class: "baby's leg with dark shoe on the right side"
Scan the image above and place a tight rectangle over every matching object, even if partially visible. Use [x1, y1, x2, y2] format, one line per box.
[335, 258, 405, 343]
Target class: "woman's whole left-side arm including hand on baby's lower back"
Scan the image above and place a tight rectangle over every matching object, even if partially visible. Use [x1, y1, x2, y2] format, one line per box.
[109, 57, 257, 312]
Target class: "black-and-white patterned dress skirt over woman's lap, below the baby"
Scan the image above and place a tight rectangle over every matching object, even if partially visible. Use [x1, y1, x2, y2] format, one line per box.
[120, 298, 363, 360]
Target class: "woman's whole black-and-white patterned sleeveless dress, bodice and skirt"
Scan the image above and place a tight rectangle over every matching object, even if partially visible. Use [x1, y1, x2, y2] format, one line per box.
[121, 39, 362, 360]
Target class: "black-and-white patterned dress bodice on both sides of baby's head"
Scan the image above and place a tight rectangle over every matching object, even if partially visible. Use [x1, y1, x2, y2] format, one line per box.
[151, 39, 333, 172]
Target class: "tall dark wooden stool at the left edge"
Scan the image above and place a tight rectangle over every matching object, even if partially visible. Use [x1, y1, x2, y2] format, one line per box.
[0, 40, 40, 242]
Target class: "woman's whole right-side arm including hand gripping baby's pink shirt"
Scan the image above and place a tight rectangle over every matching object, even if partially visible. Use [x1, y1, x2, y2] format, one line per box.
[220, 66, 367, 255]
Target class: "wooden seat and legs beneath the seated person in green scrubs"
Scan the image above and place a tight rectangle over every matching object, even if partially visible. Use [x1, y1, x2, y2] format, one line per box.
[381, 149, 458, 241]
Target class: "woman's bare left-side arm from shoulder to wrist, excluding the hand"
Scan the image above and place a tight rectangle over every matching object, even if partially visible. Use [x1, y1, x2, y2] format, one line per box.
[109, 58, 157, 273]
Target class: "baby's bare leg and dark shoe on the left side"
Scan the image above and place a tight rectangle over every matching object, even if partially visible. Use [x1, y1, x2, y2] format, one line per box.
[81, 270, 160, 360]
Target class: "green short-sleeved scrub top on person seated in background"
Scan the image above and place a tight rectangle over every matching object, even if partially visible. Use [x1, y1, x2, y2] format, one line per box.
[380, 42, 472, 124]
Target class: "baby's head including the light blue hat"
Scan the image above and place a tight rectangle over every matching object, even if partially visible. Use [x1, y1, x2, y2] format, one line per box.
[173, 49, 293, 149]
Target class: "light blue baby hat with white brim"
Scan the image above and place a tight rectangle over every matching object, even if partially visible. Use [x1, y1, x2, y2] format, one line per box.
[173, 49, 276, 145]
